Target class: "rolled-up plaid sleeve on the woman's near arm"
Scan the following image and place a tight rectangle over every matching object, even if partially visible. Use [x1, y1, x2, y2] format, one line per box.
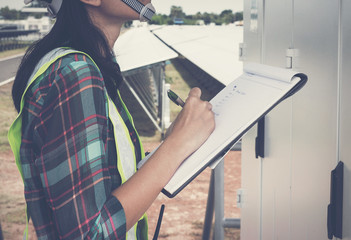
[35, 57, 126, 239]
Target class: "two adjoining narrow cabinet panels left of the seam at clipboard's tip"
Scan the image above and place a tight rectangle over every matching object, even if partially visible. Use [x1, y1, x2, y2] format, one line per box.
[241, 0, 293, 239]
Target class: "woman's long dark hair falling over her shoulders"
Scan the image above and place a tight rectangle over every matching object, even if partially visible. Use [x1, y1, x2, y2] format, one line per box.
[12, 0, 123, 111]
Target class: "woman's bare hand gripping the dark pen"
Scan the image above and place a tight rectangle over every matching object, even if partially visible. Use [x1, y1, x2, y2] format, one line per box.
[166, 88, 215, 161]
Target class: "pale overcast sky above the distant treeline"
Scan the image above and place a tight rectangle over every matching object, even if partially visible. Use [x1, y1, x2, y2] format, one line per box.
[0, 0, 244, 15]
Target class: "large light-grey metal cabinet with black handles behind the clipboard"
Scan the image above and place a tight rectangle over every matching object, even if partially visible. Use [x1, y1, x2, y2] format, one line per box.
[241, 0, 351, 240]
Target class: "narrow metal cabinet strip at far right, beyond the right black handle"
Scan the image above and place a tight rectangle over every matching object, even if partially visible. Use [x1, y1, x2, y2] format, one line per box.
[339, 0, 351, 240]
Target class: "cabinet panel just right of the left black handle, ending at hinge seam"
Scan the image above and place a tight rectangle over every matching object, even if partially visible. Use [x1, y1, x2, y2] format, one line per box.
[261, 0, 293, 239]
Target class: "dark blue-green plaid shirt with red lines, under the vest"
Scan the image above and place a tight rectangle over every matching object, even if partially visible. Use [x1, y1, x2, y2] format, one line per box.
[20, 54, 145, 239]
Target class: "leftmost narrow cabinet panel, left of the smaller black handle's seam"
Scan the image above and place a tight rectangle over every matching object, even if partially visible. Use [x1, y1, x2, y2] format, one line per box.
[240, 0, 263, 240]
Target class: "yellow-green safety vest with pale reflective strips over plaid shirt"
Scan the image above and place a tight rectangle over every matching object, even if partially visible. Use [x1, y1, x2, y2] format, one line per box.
[8, 48, 148, 240]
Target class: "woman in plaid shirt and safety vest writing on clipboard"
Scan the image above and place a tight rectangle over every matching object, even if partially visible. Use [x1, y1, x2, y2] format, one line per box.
[9, 0, 214, 239]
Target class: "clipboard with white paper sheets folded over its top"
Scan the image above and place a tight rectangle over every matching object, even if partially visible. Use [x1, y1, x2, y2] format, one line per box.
[140, 63, 308, 198]
